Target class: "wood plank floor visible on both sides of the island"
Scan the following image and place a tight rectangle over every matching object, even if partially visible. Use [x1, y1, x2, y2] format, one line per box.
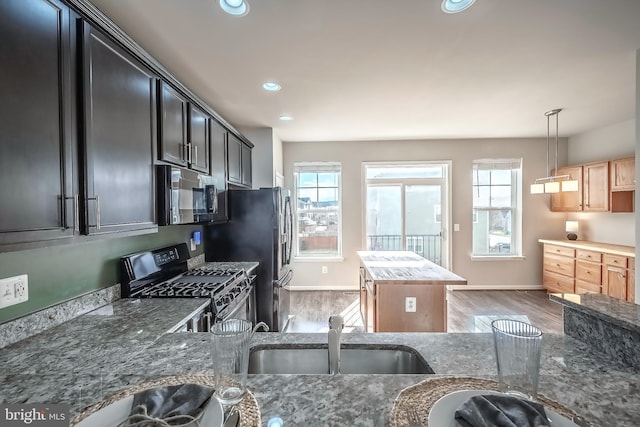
[286, 291, 562, 334]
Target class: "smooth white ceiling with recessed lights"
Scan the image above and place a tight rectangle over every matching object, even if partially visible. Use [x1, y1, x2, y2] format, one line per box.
[86, 0, 640, 141]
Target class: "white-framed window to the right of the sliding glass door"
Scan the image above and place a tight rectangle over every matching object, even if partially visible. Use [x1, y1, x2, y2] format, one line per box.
[472, 159, 522, 257]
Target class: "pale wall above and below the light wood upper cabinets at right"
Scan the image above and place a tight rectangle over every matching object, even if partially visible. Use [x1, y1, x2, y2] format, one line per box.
[567, 119, 636, 246]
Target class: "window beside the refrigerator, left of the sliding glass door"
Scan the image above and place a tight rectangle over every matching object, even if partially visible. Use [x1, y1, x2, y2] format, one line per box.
[293, 162, 342, 258]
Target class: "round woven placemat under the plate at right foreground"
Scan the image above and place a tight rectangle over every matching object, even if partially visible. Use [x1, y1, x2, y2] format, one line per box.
[390, 377, 576, 427]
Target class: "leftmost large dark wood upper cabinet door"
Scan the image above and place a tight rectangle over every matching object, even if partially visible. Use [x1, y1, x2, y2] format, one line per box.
[0, 0, 77, 245]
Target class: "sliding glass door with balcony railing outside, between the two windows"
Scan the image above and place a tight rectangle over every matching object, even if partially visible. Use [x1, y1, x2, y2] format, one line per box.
[363, 162, 451, 268]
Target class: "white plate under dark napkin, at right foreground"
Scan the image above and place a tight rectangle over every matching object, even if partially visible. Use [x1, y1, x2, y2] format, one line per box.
[429, 390, 577, 427]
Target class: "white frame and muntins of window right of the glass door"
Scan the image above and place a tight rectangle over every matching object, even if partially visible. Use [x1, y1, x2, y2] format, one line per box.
[471, 158, 523, 259]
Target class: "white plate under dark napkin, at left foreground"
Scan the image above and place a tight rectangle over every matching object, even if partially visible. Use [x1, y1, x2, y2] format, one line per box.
[76, 395, 224, 427]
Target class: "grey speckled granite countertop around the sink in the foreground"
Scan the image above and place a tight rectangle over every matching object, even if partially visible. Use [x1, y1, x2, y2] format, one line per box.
[0, 299, 640, 426]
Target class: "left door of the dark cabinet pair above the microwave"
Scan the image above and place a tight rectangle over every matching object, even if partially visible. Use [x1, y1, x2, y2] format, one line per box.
[160, 81, 188, 166]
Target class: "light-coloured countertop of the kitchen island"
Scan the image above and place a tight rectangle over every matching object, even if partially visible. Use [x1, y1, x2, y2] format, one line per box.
[358, 251, 467, 285]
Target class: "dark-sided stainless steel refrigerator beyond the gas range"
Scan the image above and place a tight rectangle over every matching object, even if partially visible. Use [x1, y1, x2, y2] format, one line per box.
[204, 187, 293, 332]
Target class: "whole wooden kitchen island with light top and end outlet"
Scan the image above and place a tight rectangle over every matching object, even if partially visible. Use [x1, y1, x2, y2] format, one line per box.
[358, 251, 467, 332]
